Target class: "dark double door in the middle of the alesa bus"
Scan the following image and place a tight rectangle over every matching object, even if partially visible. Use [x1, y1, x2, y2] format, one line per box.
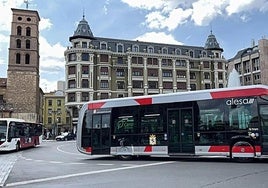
[168, 108, 194, 155]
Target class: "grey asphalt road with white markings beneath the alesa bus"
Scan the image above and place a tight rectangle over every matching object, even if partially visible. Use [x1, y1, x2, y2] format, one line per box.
[5, 141, 268, 188]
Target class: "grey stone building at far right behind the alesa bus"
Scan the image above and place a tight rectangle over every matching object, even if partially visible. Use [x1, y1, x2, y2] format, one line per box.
[228, 38, 268, 85]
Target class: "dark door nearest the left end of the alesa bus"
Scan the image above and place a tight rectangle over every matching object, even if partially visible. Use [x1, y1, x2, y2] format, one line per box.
[91, 114, 111, 155]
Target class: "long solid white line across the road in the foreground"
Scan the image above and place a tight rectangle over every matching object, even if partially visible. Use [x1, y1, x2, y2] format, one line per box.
[6, 161, 174, 187]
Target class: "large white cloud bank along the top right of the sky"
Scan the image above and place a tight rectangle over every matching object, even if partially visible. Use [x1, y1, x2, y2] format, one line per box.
[121, 0, 268, 31]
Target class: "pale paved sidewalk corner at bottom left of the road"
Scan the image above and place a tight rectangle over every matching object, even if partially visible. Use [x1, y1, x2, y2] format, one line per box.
[0, 152, 20, 187]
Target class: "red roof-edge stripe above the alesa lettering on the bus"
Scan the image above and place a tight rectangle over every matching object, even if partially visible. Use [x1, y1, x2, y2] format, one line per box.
[210, 88, 268, 99]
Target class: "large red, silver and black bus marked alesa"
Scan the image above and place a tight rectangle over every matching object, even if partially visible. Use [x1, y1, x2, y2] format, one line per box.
[77, 85, 268, 161]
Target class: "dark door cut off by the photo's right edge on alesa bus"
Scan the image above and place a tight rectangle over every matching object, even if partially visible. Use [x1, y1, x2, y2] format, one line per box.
[260, 105, 268, 155]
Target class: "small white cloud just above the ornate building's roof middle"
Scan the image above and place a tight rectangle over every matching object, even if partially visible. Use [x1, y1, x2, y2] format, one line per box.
[134, 32, 183, 45]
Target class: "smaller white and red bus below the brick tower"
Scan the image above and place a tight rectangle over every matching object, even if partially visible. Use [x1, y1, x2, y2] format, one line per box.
[0, 118, 42, 151]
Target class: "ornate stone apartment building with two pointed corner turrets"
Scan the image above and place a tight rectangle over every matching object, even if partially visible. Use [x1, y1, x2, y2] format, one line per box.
[64, 16, 227, 129]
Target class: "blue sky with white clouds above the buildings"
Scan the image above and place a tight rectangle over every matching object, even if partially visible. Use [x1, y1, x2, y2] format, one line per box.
[0, 0, 268, 92]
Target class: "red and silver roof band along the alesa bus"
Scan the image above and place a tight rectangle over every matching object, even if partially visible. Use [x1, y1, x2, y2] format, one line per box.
[85, 85, 268, 110]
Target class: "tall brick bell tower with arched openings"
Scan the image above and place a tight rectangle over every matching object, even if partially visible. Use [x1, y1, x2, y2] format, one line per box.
[7, 8, 41, 122]
